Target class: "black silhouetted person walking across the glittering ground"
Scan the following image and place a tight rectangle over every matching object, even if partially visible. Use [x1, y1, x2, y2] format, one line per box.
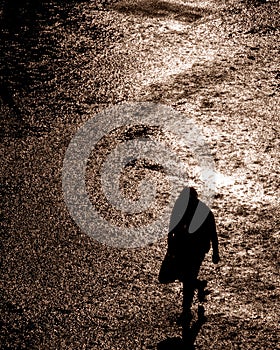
[159, 187, 220, 341]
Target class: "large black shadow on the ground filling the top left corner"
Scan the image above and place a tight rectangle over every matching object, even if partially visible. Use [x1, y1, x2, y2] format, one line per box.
[0, 0, 85, 138]
